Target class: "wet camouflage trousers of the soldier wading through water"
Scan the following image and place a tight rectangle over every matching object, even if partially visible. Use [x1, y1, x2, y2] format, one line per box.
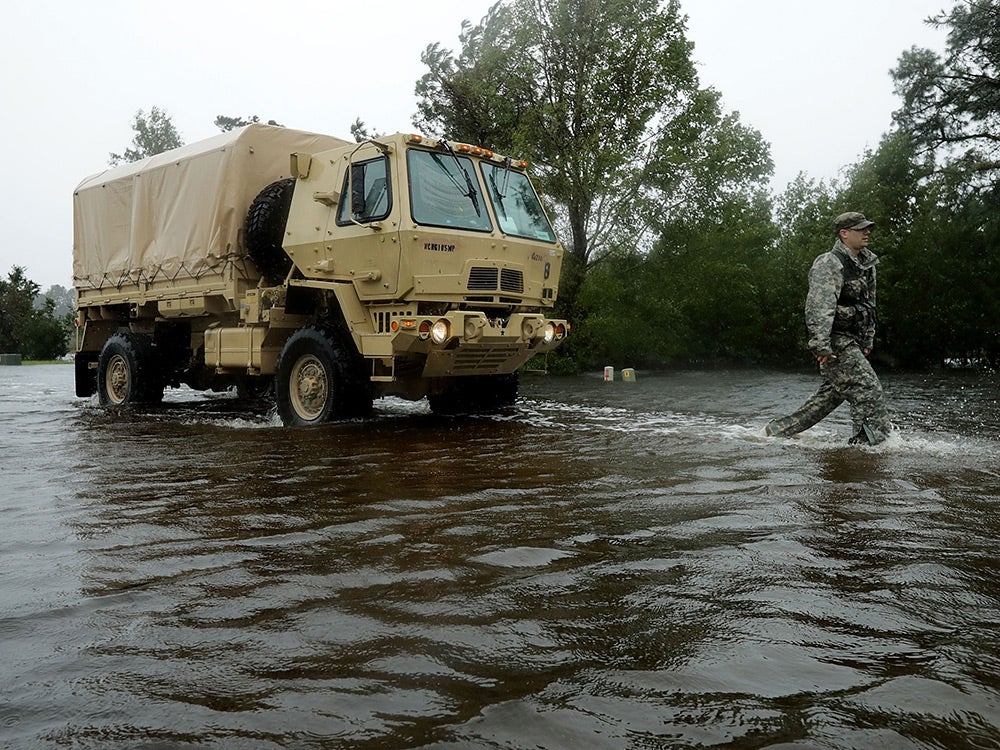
[767, 344, 892, 445]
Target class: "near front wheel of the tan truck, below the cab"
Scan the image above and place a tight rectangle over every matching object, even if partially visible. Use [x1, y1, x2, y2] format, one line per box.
[274, 326, 372, 426]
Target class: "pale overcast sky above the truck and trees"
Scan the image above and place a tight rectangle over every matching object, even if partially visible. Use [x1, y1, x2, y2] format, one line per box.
[0, 0, 952, 289]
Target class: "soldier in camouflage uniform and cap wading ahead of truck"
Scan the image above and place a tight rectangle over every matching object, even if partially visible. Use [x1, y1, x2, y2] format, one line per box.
[765, 211, 891, 445]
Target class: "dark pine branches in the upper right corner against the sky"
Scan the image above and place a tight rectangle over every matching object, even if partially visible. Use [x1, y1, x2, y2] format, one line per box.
[892, 0, 1000, 190]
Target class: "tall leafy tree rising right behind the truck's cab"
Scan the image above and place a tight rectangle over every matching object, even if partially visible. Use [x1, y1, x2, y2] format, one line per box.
[414, 0, 771, 314]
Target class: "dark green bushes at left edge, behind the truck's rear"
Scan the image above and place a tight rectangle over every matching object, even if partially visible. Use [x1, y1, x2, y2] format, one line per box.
[0, 266, 71, 359]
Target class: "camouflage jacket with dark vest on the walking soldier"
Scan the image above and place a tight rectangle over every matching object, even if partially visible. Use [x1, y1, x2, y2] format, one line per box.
[806, 239, 878, 357]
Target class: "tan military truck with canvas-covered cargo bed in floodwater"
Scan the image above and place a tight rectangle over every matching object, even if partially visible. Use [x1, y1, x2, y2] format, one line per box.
[73, 125, 569, 425]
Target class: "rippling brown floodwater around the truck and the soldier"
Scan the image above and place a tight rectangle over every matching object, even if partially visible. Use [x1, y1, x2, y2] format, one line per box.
[0, 366, 1000, 750]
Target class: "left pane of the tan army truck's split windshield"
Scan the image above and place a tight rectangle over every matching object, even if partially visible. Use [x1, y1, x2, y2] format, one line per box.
[406, 149, 493, 232]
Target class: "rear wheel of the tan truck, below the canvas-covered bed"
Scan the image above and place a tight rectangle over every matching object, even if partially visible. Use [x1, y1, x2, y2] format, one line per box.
[97, 332, 163, 406]
